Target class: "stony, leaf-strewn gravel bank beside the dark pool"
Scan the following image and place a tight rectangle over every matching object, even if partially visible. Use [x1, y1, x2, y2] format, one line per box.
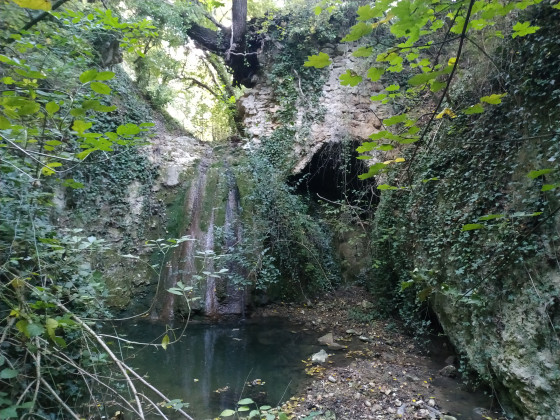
[255, 288, 502, 420]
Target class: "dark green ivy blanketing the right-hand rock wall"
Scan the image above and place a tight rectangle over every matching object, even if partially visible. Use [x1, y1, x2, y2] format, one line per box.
[369, 5, 560, 380]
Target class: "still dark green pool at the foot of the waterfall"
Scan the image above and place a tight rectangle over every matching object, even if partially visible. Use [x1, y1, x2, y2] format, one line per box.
[117, 318, 320, 420]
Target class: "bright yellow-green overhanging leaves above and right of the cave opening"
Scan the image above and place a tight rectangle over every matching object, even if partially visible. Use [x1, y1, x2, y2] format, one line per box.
[328, 0, 540, 165]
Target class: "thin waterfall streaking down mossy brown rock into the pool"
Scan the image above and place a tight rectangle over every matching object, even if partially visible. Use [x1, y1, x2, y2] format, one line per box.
[152, 154, 248, 320]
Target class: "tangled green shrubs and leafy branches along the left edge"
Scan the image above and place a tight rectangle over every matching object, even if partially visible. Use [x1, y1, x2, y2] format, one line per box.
[0, 2, 174, 418]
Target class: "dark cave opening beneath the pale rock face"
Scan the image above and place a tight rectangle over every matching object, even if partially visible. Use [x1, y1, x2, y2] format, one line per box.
[290, 141, 378, 208]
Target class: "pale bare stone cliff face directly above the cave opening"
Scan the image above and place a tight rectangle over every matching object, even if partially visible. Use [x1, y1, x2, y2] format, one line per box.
[238, 44, 392, 173]
